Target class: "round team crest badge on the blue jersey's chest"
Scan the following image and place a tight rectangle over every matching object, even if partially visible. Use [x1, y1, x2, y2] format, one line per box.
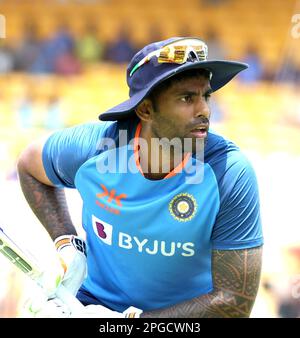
[169, 193, 197, 222]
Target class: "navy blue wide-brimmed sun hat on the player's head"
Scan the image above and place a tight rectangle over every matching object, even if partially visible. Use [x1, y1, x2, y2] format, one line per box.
[99, 37, 248, 121]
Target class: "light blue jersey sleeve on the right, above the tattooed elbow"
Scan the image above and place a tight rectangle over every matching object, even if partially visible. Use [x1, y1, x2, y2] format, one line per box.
[212, 155, 263, 250]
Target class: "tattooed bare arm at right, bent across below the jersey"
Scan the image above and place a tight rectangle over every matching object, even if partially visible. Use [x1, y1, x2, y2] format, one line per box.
[141, 247, 262, 318]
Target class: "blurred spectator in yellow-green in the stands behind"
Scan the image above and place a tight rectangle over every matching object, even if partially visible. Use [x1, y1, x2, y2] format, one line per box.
[76, 24, 104, 63]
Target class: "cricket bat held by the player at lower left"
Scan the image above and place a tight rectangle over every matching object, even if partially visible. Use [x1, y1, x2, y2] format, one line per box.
[0, 228, 84, 315]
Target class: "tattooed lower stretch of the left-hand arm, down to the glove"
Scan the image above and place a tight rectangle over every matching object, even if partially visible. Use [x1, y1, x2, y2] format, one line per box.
[19, 171, 76, 240]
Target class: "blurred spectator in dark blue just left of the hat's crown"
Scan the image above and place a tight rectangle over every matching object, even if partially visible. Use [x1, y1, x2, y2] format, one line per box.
[106, 28, 135, 63]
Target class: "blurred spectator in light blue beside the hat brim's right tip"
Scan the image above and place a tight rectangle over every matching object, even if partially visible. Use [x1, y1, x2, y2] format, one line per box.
[238, 46, 263, 83]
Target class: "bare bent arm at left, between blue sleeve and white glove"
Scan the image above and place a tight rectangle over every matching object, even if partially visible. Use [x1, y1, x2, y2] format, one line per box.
[17, 141, 76, 240]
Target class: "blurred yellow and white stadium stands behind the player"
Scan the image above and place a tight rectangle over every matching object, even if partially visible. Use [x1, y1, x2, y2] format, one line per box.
[0, 0, 300, 317]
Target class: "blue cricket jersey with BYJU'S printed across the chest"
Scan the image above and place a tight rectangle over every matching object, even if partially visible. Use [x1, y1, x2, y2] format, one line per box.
[43, 119, 263, 312]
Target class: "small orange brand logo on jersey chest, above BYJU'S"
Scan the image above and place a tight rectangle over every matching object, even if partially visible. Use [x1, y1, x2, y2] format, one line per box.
[96, 184, 127, 215]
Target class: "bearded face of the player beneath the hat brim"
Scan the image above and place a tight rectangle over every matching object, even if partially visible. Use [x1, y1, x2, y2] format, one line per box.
[151, 76, 211, 152]
